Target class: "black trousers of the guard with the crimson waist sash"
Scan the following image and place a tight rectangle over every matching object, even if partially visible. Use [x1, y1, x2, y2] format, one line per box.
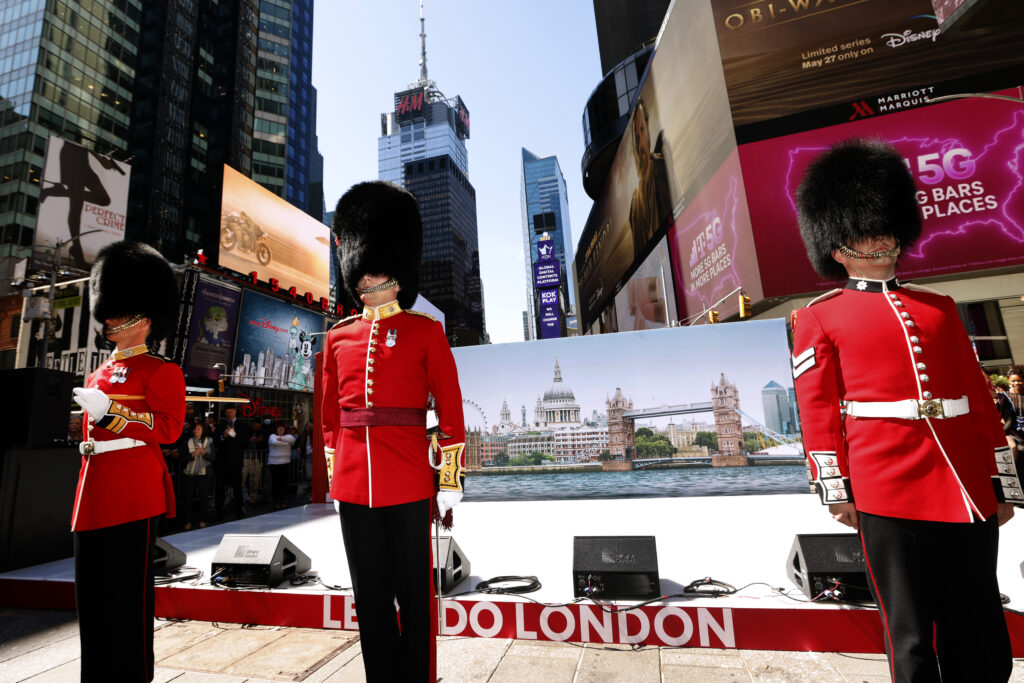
[339, 499, 437, 683]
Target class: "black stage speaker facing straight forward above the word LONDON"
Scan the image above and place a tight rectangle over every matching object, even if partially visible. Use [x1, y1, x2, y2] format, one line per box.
[572, 536, 662, 599]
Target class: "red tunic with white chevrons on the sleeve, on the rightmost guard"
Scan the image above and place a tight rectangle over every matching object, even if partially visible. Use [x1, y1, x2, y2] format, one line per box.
[793, 279, 1020, 522]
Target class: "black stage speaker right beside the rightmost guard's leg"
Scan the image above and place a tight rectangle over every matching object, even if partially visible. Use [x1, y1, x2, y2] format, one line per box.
[785, 533, 873, 602]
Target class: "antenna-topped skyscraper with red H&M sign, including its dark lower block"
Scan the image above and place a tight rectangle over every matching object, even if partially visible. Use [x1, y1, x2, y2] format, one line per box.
[377, 0, 487, 346]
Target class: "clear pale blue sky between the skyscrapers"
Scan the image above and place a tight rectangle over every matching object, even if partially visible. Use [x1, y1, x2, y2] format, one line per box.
[312, 0, 601, 342]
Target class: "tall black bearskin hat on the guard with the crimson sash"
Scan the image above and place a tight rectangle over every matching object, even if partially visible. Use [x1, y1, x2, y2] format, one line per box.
[331, 180, 423, 308]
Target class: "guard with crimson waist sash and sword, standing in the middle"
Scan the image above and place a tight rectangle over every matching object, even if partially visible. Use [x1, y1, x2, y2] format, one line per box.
[321, 181, 466, 681]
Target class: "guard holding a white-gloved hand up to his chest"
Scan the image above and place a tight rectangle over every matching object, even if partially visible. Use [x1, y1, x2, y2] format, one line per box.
[72, 242, 185, 681]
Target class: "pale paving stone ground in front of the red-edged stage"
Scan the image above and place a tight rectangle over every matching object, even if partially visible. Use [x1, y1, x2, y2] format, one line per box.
[0, 608, 1024, 683]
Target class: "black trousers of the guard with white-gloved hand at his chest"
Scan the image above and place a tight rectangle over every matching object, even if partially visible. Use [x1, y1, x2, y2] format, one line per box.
[75, 517, 160, 683]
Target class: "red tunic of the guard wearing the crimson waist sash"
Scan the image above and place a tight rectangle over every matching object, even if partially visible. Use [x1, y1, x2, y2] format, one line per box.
[322, 302, 466, 507]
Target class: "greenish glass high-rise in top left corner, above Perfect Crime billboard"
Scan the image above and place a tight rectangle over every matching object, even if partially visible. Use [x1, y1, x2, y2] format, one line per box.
[0, 0, 144, 278]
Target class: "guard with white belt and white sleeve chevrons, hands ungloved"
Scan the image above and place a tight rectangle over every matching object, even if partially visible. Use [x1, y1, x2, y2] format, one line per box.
[793, 140, 1022, 681]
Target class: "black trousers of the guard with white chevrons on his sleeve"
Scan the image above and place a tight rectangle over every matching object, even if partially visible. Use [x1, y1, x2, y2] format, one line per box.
[859, 512, 1013, 683]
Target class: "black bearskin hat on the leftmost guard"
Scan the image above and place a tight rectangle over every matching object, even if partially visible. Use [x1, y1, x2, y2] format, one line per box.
[89, 241, 180, 340]
